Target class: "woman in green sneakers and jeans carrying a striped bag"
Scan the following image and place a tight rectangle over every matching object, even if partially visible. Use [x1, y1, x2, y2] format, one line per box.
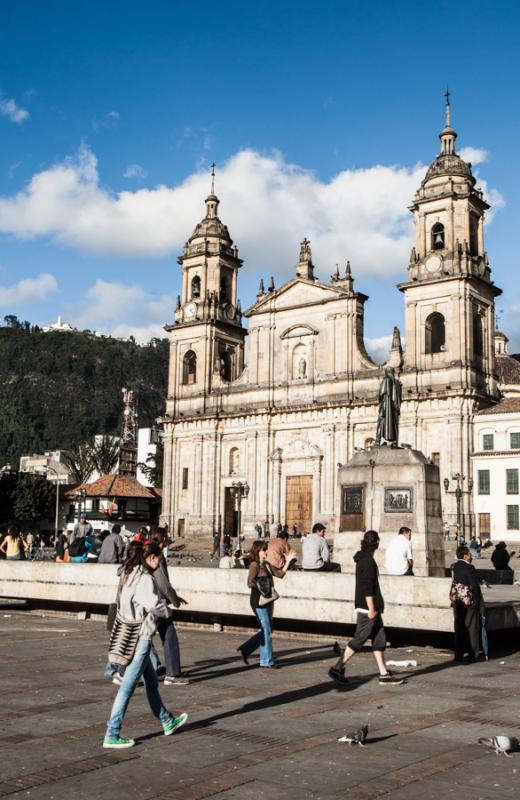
[103, 542, 188, 749]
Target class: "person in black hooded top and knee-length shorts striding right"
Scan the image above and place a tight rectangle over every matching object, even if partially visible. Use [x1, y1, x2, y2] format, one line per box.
[329, 531, 404, 684]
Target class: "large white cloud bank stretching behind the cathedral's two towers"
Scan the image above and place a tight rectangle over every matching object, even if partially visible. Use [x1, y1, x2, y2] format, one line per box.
[0, 145, 501, 278]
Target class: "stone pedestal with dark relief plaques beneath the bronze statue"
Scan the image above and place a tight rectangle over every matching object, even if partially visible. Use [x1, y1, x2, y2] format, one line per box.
[333, 445, 445, 577]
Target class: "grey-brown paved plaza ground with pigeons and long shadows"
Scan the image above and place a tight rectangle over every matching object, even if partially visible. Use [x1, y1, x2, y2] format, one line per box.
[0, 604, 520, 800]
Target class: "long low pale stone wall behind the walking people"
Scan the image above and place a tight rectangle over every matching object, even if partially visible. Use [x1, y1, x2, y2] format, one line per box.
[0, 561, 520, 631]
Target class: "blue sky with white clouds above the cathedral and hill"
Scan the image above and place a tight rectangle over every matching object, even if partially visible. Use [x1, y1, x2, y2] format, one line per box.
[0, 0, 520, 351]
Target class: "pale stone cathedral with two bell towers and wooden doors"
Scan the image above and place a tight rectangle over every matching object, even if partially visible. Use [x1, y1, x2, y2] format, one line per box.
[162, 97, 501, 536]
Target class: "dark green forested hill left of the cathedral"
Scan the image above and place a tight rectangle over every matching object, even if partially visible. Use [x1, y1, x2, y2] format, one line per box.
[0, 317, 168, 467]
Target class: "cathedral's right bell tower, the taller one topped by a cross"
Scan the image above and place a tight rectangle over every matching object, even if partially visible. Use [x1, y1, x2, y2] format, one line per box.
[399, 91, 501, 397]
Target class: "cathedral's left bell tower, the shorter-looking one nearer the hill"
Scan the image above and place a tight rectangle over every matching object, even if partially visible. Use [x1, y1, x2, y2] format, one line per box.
[166, 164, 246, 416]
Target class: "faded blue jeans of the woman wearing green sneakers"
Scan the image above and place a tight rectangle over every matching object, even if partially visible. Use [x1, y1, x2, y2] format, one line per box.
[106, 639, 172, 737]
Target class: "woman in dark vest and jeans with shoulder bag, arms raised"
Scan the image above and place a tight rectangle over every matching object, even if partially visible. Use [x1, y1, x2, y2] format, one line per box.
[238, 539, 296, 669]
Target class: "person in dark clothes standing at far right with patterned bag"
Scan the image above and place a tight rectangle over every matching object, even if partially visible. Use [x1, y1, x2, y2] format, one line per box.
[452, 545, 484, 663]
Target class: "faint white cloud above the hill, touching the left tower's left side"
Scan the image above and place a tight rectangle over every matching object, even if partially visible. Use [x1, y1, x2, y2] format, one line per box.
[74, 279, 174, 342]
